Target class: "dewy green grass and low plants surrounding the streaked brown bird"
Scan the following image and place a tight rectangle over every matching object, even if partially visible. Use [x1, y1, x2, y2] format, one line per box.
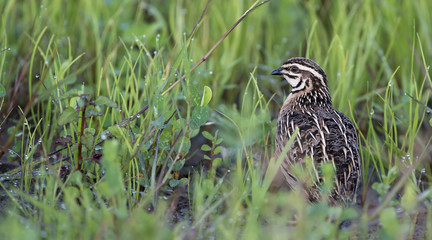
[0, 0, 432, 239]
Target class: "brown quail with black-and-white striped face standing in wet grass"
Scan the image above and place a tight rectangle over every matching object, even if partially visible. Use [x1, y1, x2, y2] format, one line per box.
[271, 57, 361, 204]
